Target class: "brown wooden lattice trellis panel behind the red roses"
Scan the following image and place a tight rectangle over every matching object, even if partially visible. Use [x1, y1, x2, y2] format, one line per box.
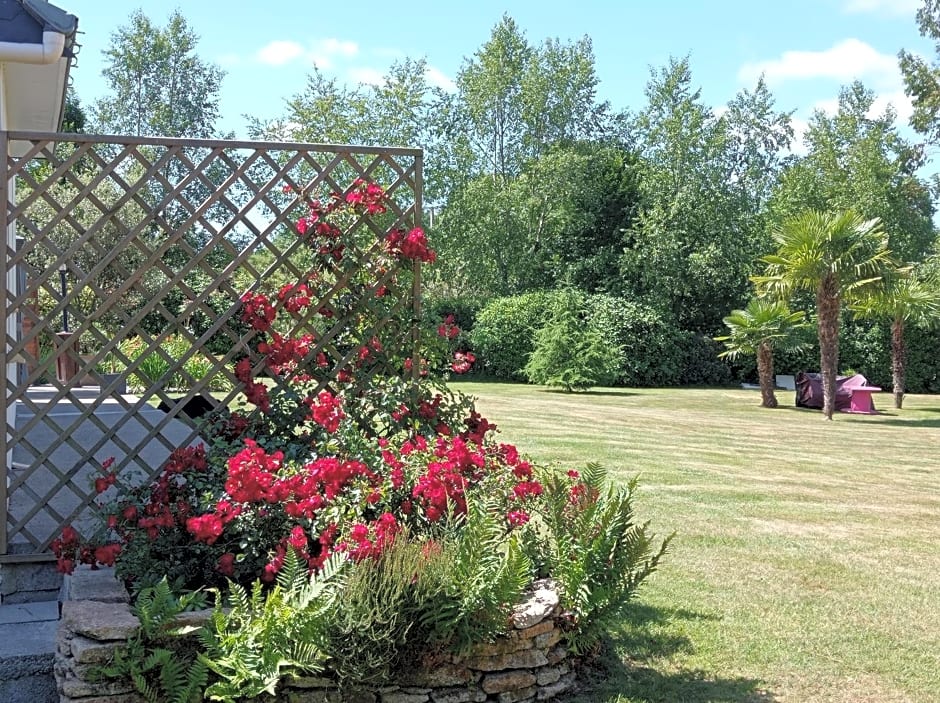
[0, 132, 422, 561]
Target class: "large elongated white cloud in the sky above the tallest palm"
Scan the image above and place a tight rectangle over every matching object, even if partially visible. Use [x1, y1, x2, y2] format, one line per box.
[738, 39, 898, 84]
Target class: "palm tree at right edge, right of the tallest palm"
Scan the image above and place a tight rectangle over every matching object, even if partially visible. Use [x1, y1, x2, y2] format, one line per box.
[851, 267, 940, 410]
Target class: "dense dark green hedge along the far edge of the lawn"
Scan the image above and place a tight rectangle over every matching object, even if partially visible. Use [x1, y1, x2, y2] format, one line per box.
[470, 291, 940, 393]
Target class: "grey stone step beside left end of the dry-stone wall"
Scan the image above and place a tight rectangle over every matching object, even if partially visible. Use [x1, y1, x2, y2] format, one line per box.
[0, 601, 59, 703]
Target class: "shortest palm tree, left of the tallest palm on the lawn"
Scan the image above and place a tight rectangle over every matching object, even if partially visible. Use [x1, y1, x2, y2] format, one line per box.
[715, 298, 805, 408]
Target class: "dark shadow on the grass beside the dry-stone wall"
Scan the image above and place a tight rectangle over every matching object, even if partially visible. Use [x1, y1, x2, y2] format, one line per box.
[569, 603, 777, 703]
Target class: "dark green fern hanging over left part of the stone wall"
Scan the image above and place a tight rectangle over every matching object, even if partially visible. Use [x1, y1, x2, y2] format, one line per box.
[96, 579, 208, 703]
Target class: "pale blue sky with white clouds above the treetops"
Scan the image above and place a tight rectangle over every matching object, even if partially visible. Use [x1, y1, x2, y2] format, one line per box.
[62, 0, 933, 146]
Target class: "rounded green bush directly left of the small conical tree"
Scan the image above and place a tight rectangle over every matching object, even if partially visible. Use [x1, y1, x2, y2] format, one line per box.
[470, 292, 553, 381]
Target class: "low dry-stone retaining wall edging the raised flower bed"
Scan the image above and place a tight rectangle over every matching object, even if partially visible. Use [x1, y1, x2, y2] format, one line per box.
[55, 570, 575, 703]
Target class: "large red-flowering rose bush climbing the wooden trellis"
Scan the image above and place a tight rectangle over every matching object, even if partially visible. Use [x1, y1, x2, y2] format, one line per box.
[53, 180, 665, 688]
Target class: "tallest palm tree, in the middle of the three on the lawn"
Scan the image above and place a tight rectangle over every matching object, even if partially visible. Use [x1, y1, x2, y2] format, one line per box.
[751, 210, 891, 420]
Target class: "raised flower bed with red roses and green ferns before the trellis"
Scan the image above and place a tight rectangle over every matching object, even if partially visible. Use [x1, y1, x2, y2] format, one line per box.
[53, 181, 668, 703]
